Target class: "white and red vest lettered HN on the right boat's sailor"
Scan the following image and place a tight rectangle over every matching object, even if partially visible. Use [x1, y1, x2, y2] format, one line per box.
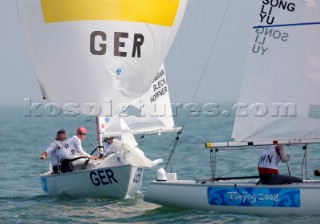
[258, 145, 280, 174]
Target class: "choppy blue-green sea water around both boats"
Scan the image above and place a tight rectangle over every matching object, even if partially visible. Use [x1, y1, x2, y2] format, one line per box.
[0, 106, 320, 224]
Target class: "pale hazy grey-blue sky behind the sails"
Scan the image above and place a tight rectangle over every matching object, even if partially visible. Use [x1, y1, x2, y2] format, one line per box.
[0, 0, 256, 105]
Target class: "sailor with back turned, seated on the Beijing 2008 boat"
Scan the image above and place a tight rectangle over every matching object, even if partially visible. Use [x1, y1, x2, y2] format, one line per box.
[258, 145, 302, 185]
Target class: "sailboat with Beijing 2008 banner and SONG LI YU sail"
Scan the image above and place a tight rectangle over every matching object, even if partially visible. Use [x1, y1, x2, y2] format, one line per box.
[144, 0, 320, 215]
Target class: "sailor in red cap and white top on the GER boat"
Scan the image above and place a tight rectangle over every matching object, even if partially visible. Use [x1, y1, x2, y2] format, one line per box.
[58, 127, 97, 173]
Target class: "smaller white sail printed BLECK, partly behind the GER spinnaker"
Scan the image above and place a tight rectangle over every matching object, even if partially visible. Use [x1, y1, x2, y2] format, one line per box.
[99, 64, 178, 136]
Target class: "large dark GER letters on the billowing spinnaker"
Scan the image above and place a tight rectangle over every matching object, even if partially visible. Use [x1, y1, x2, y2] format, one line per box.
[90, 31, 144, 58]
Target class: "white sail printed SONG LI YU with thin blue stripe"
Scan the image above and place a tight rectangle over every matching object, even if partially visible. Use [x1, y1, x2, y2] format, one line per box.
[232, 1, 320, 141]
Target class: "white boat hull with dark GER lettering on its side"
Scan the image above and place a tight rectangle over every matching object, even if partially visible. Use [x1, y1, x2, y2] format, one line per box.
[41, 156, 143, 198]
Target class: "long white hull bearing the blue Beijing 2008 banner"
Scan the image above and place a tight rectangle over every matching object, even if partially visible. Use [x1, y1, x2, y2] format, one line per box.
[144, 179, 320, 215]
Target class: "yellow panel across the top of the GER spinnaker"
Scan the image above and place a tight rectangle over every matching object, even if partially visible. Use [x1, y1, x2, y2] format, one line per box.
[41, 0, 180, 27]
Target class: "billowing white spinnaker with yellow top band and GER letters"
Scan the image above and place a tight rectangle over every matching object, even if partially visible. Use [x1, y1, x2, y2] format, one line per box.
[17, 0, 187, 115]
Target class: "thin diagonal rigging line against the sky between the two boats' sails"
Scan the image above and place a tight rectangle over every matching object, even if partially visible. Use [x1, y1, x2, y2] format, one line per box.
[182, 0, 232, 129]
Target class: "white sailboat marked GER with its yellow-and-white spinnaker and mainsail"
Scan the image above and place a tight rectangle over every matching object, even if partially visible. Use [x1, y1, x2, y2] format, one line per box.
[17, 0, 187, 198]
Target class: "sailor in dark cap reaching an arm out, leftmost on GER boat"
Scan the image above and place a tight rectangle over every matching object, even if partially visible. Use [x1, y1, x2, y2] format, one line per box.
[40, 129, 67, 174]
